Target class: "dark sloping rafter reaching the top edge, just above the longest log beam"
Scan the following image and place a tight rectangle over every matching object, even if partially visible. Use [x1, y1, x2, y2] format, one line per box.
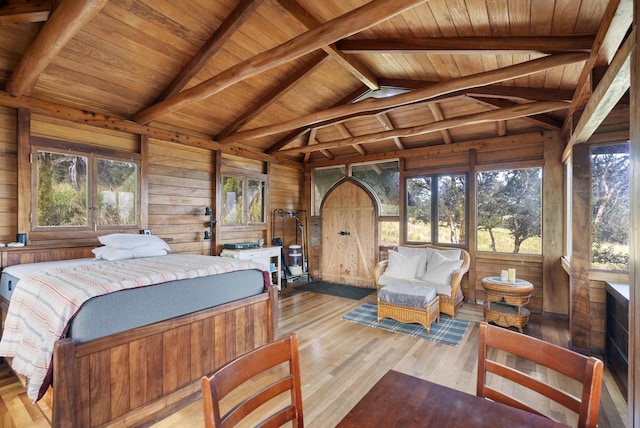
[156, 0, 263, 102]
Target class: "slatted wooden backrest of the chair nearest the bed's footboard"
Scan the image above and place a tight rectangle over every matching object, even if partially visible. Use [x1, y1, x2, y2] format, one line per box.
[201, 333, 304, 428]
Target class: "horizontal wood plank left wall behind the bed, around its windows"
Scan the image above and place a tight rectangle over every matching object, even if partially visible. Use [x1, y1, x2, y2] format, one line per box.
[0, 107, 304, 254]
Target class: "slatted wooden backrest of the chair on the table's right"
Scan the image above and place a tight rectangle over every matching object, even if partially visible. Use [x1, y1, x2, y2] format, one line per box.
[476, 323, 603, 427]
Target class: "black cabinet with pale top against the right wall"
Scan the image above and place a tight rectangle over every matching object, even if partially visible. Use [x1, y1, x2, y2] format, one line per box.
[605, 282, 629, 399]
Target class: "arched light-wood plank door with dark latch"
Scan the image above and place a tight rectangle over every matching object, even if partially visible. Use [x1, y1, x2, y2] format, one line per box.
[321, 181, 377, 287]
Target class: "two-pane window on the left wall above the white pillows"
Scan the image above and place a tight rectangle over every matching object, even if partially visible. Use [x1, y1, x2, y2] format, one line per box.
[32, 146, 140, 230]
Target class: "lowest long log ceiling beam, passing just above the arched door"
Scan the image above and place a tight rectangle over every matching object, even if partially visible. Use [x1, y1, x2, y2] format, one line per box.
[279, 101, 569, 155]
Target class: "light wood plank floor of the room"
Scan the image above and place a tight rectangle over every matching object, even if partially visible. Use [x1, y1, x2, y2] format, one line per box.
[0, 289, 627, 428]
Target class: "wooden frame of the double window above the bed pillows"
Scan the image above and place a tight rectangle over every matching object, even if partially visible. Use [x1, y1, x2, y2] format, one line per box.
[28, 137, 144, 239]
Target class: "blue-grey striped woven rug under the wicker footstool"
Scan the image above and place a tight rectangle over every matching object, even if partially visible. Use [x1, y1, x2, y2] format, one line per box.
[342, 303, 469, 346]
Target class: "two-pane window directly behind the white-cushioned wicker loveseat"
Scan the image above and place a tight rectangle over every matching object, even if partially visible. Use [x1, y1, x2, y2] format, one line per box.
[405, 174, 467, 244]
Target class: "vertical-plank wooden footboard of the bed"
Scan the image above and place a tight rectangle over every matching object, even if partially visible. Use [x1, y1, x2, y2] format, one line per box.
[49, 287, 278, 427]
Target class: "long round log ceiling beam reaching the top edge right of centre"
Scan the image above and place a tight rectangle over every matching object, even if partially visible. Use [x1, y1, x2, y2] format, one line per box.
[136, 0, 426, 124]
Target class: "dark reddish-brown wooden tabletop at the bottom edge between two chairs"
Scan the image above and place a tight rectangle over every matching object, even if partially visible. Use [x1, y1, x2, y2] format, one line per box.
[337, 370, 566, 428]
